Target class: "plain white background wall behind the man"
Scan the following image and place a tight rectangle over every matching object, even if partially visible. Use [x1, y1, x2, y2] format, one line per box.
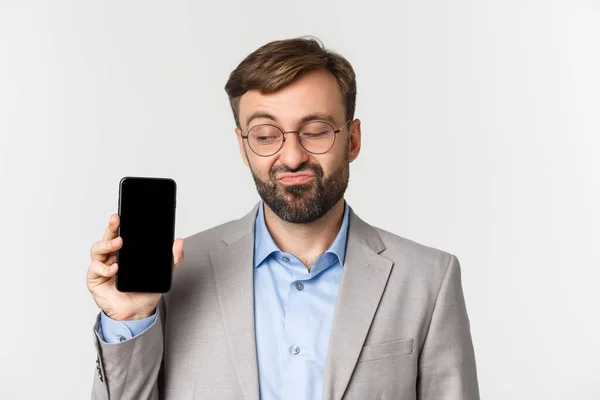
[0, 0, 600, 400]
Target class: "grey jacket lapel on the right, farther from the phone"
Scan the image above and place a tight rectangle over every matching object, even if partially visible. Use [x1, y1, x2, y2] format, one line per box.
[323, 211, 393, 400]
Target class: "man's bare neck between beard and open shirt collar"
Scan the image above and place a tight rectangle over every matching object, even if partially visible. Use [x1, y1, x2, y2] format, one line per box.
[264, 199, 345, 271]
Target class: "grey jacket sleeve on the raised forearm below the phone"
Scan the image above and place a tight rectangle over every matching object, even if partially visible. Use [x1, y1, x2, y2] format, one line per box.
[91, 296, 167, 400]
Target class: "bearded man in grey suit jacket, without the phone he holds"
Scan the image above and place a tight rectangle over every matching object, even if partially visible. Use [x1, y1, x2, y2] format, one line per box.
[87, 38, 479, 400]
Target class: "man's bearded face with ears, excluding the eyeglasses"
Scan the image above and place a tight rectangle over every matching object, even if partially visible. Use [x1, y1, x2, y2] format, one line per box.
[236, 70, 360, 223]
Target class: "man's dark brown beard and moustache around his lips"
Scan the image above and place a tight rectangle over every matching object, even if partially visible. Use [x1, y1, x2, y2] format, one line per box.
[250, 149, 350, 224]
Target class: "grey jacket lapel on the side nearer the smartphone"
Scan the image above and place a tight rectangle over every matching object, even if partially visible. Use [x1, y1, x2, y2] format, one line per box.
[210, 207, 259, 400]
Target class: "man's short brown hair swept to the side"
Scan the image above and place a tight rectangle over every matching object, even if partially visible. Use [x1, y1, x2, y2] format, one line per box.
[225, 37, 356, 127]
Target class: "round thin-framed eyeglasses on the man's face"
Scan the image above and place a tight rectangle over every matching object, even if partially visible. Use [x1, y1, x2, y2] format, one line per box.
[240, 119, 351, 157]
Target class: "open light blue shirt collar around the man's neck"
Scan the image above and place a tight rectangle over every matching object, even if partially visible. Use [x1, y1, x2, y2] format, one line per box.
[254, 200, 350, 268]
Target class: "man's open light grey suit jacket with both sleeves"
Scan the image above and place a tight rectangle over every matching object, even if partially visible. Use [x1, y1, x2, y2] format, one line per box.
[92, 206, 479, 400]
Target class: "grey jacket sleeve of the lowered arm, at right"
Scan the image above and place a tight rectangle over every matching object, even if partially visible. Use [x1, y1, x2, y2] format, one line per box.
[417, 255, 479, 400]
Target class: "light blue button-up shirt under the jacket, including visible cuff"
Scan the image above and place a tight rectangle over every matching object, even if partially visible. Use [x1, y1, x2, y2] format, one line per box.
[99, 201, 349, 400]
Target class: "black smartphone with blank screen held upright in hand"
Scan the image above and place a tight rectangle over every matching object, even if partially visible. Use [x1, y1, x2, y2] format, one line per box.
[115, 176, 177, 293]
